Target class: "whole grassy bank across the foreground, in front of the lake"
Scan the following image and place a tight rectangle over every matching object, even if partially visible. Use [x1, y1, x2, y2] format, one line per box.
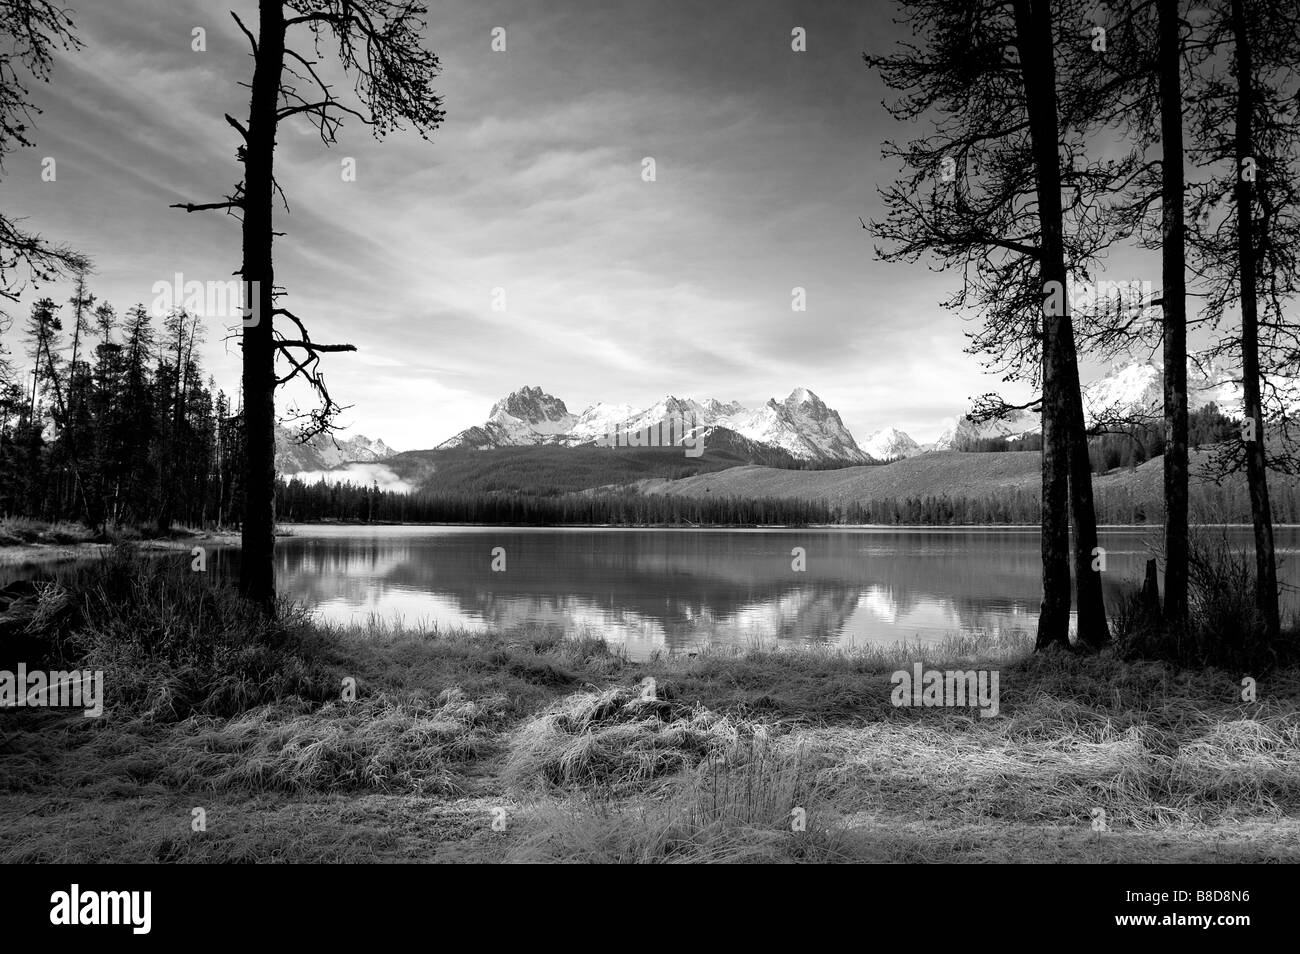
[0, 558, 1300, 862]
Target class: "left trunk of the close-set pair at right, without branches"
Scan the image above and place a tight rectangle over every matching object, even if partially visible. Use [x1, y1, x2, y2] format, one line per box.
[1014, 0, 1070, 650]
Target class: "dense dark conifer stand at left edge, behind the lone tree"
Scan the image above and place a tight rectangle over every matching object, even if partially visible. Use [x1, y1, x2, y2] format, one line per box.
[0, 285, 243, 533]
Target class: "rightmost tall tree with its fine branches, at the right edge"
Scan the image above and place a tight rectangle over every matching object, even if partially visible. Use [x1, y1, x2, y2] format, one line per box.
[1190, 0, 1300, 639]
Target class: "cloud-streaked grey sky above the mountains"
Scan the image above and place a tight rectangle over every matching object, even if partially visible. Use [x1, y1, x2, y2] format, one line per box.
[0, 0, 1158, 450]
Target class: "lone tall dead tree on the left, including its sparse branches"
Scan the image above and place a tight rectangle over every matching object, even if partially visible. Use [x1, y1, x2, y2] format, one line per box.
[177, 0, 443, 612]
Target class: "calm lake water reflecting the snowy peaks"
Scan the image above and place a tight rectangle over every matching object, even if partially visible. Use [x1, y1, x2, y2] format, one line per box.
[200, 526, 1300, 656]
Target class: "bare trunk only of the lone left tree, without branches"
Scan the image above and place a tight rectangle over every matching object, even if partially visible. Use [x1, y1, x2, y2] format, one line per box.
[239, 0, 285, 612]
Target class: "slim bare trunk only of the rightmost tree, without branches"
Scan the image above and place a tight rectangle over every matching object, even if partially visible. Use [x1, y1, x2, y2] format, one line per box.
[1232, 0, 1281, 641]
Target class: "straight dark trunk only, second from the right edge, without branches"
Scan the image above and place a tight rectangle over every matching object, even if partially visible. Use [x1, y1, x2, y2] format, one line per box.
[1157, 0, 1188, 632]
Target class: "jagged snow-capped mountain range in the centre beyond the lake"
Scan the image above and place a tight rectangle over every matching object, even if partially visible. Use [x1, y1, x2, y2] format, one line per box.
[438, 387, 870, 463]
